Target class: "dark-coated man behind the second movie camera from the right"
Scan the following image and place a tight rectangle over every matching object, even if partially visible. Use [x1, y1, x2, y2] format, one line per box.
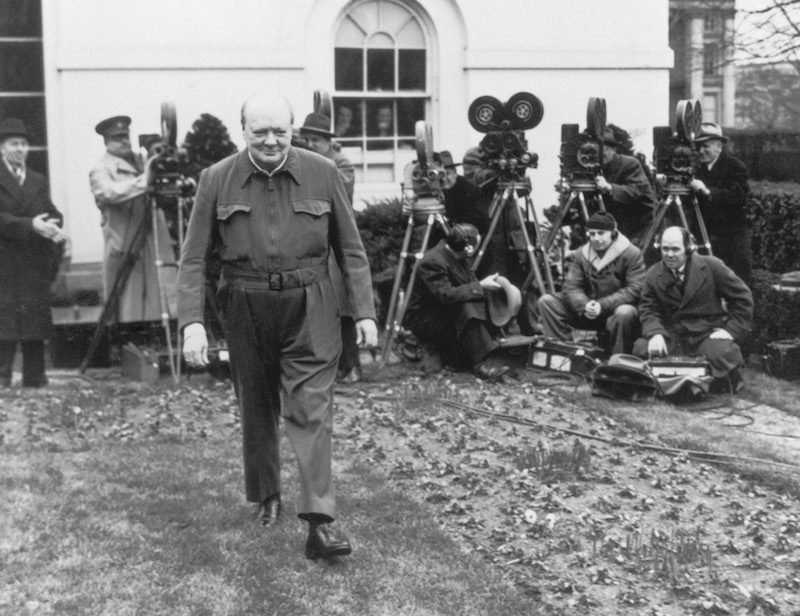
[595, 126, 655, 249]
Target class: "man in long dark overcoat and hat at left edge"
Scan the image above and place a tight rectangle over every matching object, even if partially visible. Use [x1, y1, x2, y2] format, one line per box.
[0, 118, 66, 387]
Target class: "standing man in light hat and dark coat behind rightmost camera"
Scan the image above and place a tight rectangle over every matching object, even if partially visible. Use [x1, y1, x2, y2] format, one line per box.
[692, 122, 753, 286]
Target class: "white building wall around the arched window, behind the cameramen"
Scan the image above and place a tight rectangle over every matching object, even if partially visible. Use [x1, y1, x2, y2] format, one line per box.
[43, 0, 672, 263]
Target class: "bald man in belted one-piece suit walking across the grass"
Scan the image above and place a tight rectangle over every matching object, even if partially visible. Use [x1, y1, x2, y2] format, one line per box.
[178, 94, 377, 559]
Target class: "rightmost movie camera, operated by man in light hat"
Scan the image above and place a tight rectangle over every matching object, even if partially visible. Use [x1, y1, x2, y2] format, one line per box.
[653, 99, 703, 195]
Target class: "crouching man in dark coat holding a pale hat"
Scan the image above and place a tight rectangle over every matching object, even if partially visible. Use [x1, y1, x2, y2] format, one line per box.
[405, 223, 510, 379]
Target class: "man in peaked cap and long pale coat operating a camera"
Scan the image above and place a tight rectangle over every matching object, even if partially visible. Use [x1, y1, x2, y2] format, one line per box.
[89, 116, 177, 323]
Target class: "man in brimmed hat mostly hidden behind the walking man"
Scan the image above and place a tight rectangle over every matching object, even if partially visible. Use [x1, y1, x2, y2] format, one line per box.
[300, 113, 361, 384]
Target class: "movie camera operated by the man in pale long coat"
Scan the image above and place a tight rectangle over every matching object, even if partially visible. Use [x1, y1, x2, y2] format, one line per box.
[139, 102, 196, 200]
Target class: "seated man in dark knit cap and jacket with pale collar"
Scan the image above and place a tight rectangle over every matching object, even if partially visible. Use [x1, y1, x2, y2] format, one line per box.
[538, 212, 645, 354]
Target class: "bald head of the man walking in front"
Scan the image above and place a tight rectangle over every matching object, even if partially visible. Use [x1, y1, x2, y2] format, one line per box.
[242, 93, 294, 170]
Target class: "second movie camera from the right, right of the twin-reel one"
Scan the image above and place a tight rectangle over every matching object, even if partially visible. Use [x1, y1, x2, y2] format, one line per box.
[561, 97, 606, 190]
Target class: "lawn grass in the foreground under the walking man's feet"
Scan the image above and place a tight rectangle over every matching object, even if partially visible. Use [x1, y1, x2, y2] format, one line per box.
[0, 428, 535, 616]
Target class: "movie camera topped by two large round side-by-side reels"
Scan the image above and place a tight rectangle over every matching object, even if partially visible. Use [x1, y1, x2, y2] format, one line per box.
[467, 92, 544, 181]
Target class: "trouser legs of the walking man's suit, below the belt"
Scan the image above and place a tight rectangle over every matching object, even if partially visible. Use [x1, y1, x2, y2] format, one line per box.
[220, 279, 341, 517]
